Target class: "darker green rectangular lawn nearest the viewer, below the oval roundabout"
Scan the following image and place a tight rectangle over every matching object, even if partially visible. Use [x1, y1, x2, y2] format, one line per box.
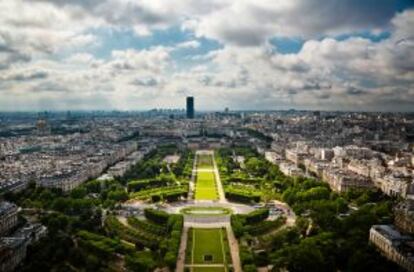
[187, 228, 228, 266]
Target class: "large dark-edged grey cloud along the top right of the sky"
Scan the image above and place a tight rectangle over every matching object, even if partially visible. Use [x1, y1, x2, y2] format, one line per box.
[185, 0, 408, 46]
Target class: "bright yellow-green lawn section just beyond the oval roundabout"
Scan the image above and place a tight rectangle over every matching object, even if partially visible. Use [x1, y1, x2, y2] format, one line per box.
[195, 171, 218, 200]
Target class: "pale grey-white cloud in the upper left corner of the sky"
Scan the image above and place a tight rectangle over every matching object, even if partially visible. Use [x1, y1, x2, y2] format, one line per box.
[0, 0, 99, 57]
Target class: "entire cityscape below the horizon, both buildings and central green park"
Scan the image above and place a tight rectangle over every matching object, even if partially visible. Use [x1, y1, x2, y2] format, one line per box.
[0, 109, 414, 272]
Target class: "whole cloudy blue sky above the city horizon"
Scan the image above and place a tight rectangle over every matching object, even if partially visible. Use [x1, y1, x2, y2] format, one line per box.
[0, 0, 414, 111]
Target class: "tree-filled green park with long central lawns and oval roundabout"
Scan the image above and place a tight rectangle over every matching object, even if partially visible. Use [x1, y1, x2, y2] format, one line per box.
[8, 145, 395, 272]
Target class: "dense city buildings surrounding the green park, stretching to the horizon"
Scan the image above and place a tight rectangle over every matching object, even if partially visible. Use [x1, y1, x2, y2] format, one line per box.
[0, 109, 414, 269]
